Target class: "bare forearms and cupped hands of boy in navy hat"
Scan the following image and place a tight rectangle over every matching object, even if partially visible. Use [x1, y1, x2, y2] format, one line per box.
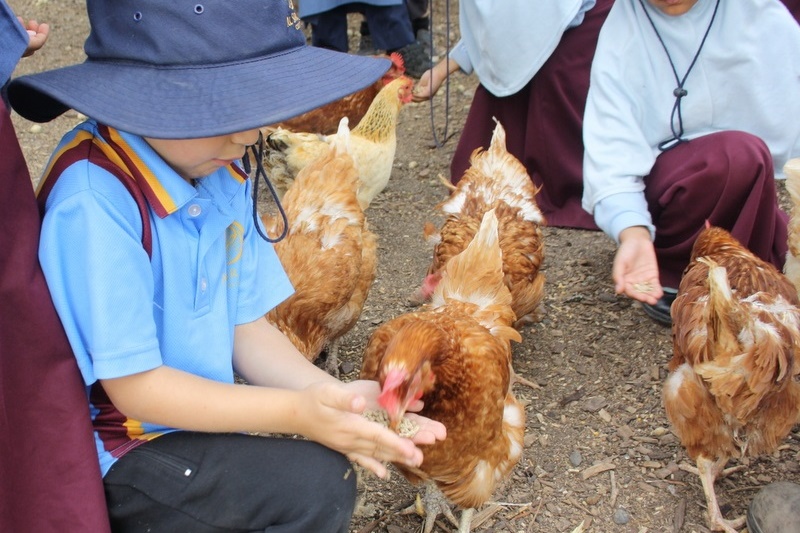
[102, 317, 445, 477]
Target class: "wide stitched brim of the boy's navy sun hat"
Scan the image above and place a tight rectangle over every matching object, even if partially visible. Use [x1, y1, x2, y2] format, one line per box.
[8, 46, 391, 139]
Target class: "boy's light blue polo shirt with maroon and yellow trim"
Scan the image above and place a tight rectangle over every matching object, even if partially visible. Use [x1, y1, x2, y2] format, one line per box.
[39, 120, 293, 475]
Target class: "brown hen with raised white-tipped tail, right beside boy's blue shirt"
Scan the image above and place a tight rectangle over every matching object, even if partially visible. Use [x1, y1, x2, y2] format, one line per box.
[262, 119, 376, 375]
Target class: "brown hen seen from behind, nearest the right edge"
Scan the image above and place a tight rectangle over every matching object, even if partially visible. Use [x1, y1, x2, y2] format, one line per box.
[664, 227, 800, 533]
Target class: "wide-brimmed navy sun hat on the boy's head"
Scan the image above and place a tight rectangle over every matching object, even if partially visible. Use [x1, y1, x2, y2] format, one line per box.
[8, 0, 391, 139]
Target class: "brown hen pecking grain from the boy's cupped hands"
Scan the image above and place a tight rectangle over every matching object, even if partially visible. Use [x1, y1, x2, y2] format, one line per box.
[361, 211, 525, 532]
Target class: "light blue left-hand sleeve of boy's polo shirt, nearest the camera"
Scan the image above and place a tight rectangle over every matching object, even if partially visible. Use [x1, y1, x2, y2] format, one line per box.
[39, 161, 162, 385]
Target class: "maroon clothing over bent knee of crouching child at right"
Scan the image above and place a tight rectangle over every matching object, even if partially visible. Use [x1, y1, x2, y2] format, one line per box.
[645, 131, 788, 288]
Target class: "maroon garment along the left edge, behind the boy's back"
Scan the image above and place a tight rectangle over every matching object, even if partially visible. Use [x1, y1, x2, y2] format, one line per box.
[0, 98, 109, 533]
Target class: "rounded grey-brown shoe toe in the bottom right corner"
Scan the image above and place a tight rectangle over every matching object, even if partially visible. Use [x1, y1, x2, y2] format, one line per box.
[747, 481, 800, 533]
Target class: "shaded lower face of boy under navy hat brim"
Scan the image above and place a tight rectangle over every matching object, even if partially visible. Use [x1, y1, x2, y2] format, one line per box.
[145, 129, 258, 180]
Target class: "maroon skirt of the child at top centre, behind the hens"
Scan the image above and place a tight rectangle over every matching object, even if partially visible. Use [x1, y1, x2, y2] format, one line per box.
[450, 0, 613, 229]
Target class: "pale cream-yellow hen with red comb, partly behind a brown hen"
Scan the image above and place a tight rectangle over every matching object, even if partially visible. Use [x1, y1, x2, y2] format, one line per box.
[263, 76, 414, 209]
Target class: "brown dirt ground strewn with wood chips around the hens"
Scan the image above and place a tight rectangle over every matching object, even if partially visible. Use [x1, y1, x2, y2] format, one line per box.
[9, 0, 800, 533]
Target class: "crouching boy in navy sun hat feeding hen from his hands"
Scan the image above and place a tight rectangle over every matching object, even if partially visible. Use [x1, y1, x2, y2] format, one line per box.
[8, 0, 445, 532]
